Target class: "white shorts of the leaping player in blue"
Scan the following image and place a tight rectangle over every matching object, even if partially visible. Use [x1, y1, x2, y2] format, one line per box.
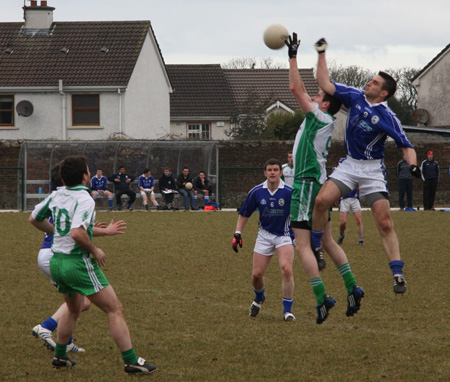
[330, 156, 389, 196]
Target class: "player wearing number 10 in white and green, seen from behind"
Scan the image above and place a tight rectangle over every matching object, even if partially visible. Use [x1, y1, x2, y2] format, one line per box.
[30, 156, 156, 374]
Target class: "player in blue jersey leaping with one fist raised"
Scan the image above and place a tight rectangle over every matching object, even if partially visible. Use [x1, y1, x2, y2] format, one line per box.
[311, 38, 420, 294]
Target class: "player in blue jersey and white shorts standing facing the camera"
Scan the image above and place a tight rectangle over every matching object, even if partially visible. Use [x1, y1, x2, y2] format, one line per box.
[232, 159, 295, 321]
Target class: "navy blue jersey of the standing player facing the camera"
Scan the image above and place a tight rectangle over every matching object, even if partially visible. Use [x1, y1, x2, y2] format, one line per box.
[239, 180, 294, 239]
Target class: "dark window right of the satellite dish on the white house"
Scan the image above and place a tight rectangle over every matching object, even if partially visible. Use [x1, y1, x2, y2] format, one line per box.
[72, 94, 100, 126]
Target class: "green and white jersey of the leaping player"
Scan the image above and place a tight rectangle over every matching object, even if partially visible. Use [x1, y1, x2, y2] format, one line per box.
[292, 104, 336, 184]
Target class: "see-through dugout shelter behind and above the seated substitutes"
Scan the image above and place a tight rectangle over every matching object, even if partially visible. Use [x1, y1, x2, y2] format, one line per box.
[14, 141, 218, 210]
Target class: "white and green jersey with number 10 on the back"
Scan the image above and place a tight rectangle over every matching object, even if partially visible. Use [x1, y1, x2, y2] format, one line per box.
[31, 185, 95, 255]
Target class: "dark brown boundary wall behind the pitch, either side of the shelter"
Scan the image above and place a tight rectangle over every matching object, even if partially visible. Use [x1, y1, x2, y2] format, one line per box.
[0, 134, 450, 209]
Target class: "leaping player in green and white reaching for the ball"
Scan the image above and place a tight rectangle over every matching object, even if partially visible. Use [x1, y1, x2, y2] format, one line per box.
[286, 33, 364, 324]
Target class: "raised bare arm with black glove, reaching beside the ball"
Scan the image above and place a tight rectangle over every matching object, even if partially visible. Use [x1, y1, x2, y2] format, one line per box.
[286, 33, 314, 113]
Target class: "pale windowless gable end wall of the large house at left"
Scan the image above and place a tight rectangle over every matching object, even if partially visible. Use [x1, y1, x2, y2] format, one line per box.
[123, 34, 171, 139]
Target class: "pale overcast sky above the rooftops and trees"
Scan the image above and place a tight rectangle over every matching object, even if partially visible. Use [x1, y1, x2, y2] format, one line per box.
[0, 0, 450, 71]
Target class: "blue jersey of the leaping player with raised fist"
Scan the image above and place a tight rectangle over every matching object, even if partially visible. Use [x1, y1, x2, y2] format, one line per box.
[334, 83, 413, 160]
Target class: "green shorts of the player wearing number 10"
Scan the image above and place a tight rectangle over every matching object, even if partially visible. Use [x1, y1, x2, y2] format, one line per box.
[50, 253, 109, 297]
